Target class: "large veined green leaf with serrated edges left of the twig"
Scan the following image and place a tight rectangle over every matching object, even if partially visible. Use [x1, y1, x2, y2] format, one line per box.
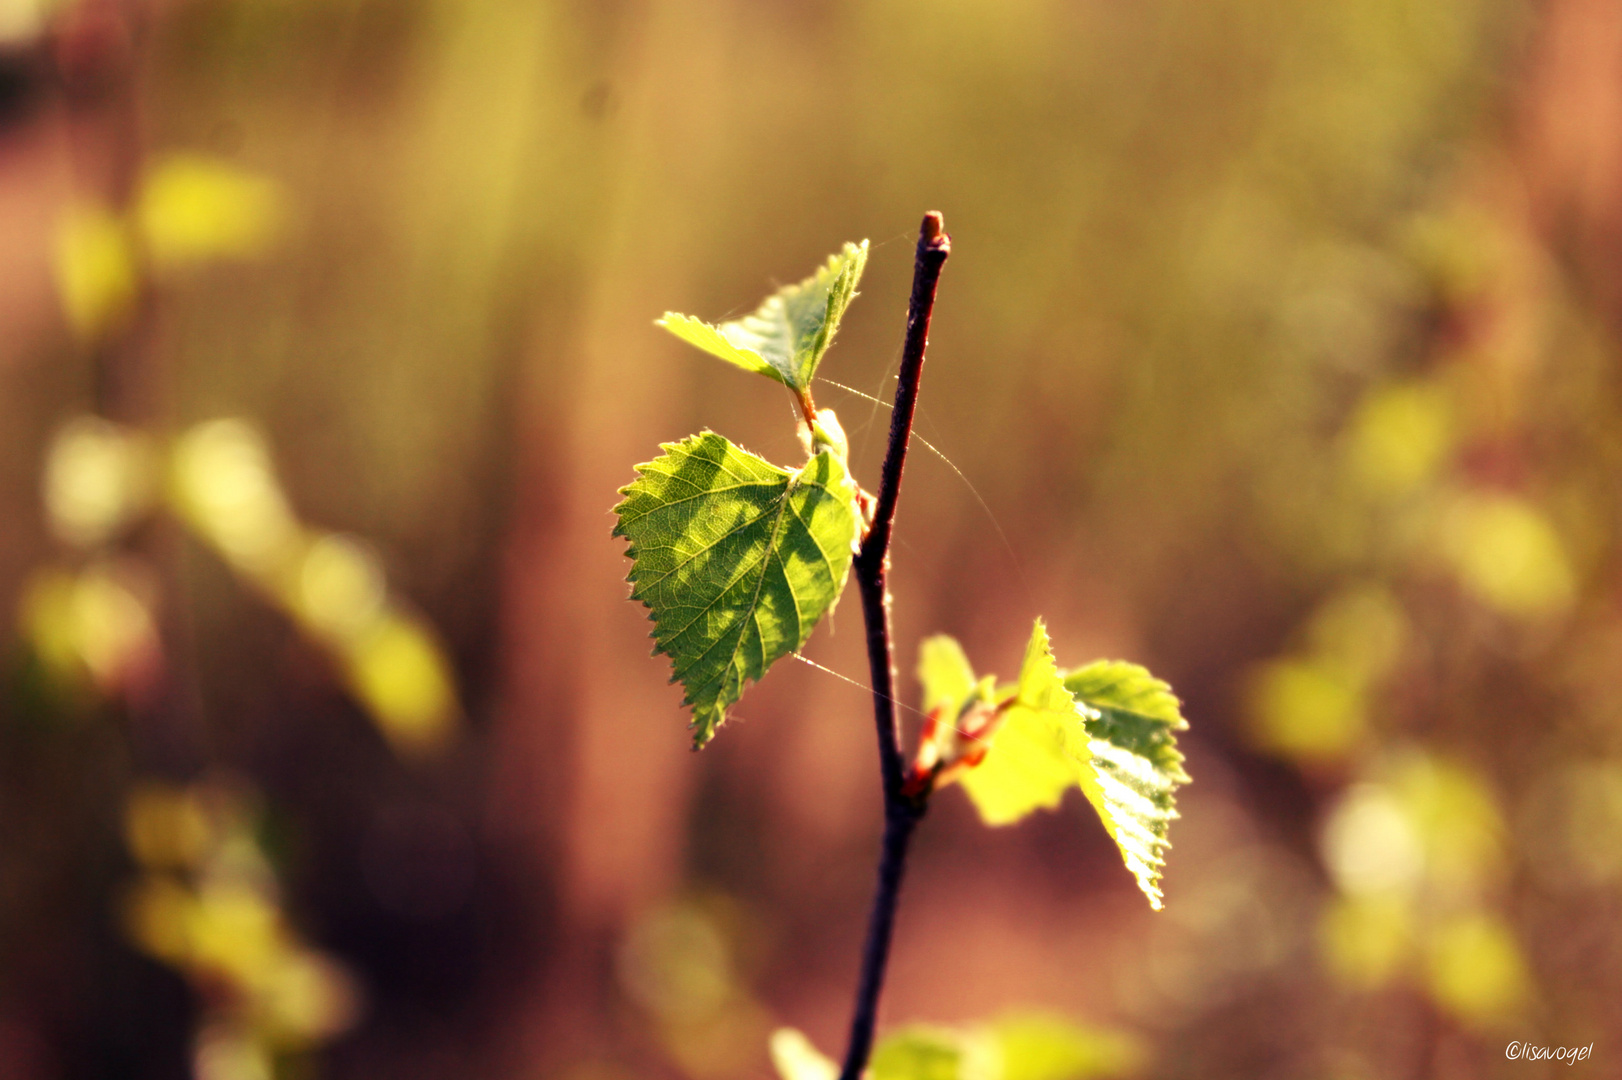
[613, 431, 861, 748]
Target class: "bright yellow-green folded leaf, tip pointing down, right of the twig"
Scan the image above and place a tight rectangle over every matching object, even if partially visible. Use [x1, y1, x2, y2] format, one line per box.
[962, 619, 1189, 910]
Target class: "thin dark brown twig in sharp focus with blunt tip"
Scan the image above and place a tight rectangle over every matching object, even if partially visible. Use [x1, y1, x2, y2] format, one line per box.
[840, 211, 952, 1080]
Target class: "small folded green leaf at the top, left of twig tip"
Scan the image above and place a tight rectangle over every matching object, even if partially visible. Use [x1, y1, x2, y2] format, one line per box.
[655, 240, 868, 391]
